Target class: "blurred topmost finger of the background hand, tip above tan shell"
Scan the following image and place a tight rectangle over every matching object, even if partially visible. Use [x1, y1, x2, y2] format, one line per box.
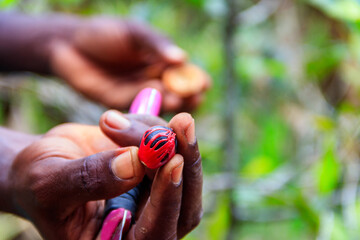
[126, 21, 187, 64]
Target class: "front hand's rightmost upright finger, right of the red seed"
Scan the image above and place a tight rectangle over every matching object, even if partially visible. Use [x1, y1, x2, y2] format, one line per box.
[169, 113, 203, 238]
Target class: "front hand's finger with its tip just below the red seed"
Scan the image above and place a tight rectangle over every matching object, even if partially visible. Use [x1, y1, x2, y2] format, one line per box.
[127, 154, 184, 239]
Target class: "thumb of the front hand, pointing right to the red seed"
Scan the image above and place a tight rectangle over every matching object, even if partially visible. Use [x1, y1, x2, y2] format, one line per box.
[58, 147, 145, 204]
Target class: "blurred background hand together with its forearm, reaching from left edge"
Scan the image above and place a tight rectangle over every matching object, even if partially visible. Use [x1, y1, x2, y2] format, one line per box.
[0, 12, 210, 112]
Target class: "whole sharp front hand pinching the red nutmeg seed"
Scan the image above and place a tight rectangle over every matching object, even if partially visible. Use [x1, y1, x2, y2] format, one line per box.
[10, 110, 202, 240]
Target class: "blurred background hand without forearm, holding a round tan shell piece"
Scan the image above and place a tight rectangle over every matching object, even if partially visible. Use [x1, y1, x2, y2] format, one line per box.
[50, 18, 207, 111]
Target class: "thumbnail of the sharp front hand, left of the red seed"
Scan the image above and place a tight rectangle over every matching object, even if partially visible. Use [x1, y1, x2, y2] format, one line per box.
[111, 148, 135, 179]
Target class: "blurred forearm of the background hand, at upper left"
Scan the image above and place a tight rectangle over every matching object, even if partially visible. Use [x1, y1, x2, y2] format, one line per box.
[0, 13, 81, 74]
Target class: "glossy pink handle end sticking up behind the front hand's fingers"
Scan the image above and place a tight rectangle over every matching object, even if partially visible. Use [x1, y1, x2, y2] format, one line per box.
[129, 88, 161, 116]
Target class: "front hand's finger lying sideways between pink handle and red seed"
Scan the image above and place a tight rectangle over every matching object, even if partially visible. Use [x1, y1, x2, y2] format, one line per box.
[99, 110, 167, 146]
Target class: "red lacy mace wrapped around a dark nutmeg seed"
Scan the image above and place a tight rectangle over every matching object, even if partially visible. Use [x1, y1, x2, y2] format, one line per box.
[139, 126, 177, 169]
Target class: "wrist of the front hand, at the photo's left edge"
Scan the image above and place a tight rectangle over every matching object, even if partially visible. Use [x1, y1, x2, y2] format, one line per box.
[0, 127, 39, 213]
